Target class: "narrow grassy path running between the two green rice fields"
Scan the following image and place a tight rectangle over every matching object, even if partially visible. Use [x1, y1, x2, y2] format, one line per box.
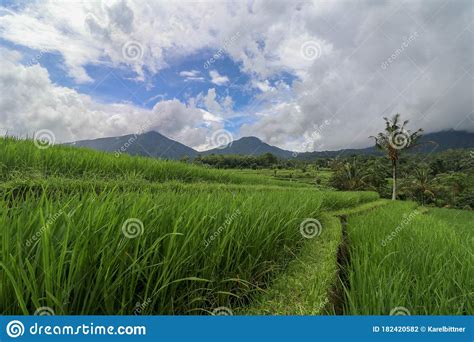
[243, 200, 390, 316]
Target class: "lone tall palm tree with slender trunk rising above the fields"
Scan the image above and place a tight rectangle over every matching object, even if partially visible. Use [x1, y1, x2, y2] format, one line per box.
[370, 113, 423, 200]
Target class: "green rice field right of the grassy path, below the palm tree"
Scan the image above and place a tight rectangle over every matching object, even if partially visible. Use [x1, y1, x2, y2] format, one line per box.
[345, 202, 474, 315]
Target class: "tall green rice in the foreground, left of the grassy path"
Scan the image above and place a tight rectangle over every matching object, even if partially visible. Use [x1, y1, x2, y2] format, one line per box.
[0, 185, 376, 314]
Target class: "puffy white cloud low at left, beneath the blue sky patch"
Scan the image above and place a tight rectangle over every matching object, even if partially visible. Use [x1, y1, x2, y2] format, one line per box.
[0, 48, 222, 147]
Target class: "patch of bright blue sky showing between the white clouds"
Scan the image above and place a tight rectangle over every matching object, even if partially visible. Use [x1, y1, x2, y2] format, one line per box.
[5, 30, 297, 133]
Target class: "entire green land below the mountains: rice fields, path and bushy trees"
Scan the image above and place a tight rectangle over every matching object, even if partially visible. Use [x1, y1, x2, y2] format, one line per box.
[0, 138, 474, 315]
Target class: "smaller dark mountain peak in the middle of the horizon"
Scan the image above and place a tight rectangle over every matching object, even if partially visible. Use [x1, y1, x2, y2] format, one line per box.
[200, 137, 293, 159]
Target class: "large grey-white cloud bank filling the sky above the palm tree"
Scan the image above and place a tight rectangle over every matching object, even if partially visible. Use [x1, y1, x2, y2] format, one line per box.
[241, 1, 474, 151]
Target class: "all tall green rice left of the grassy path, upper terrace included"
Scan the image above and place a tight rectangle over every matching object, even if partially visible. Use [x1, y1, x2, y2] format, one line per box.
[0, 138, 378, 314]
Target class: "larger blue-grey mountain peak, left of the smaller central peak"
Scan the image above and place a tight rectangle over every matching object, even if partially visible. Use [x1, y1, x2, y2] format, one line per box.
[66, 131, 197, 159]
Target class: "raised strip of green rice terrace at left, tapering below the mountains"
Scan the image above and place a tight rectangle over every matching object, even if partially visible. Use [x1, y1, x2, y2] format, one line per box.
[0, 138, 305, 187]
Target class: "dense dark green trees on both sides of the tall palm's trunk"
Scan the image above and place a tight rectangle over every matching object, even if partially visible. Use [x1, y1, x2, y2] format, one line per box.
[330, 150, 474, 209]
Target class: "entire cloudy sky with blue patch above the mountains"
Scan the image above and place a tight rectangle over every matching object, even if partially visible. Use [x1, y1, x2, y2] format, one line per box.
[0, 0, 474, 152]
